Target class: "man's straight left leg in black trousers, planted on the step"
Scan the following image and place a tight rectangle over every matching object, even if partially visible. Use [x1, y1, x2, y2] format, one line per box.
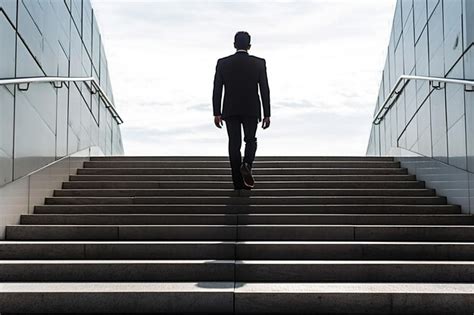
[225, 117, 244, 189]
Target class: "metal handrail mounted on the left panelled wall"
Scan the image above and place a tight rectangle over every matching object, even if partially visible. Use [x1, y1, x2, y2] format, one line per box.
[0, 77, 123, 125]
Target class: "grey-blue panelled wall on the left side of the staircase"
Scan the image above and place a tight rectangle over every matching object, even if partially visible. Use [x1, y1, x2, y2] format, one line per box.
[0, 0, 123, 186]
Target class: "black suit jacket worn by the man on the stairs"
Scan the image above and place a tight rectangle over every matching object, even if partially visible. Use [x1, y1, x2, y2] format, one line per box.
[212, 52, 270, 120]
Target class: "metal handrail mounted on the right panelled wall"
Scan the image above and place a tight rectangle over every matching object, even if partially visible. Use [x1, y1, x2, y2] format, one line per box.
[372, 75, 474, 125]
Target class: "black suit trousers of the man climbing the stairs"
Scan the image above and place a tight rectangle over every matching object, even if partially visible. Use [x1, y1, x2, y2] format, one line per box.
[225, 116, 259, 189]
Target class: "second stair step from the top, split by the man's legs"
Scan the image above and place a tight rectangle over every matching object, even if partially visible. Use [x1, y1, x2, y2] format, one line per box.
[84, 161, 400, 170]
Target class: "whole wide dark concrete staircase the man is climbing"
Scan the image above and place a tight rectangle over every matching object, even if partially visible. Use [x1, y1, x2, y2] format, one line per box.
[0, 157, 474, 314]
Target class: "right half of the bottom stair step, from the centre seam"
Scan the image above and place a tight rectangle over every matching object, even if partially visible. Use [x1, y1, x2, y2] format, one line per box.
[234, 282, 474, 314]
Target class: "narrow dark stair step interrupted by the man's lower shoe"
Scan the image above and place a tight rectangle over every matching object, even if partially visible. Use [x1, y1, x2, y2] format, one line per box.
[62, 181, 425, 189]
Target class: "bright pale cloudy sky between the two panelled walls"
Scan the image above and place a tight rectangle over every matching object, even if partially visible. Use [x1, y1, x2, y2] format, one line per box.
[93, 0, 395, 156]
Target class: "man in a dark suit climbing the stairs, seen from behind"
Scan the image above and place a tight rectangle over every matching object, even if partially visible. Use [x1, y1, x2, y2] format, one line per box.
[213, 32, 270, 190]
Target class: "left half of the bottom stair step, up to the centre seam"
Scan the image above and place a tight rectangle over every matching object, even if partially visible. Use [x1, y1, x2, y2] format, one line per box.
[0, 282, 234, 314]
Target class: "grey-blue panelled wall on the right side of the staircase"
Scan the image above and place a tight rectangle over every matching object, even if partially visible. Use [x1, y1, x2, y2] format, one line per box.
[367, 0, 474, 215]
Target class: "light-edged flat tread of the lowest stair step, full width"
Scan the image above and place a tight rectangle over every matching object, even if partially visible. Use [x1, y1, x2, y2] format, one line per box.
[0, 282, 474, 295]
